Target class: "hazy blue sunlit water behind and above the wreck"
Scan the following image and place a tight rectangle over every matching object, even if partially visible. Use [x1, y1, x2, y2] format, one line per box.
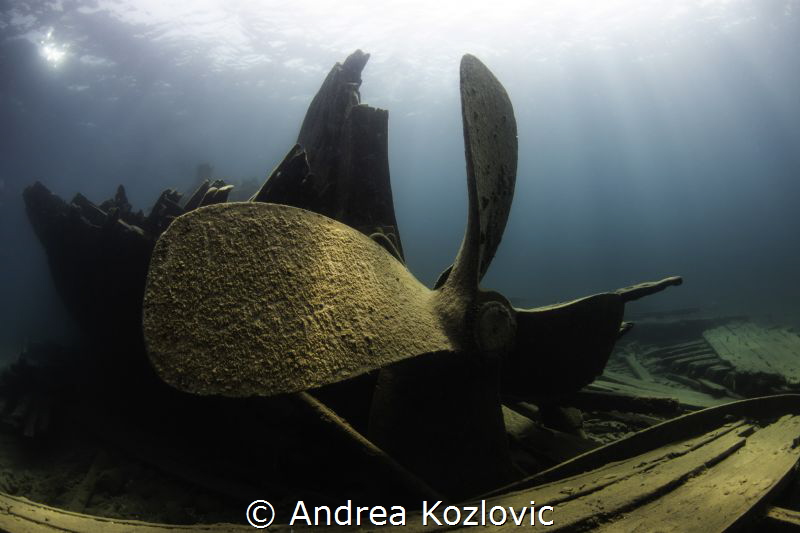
[0, 0, 800, 355]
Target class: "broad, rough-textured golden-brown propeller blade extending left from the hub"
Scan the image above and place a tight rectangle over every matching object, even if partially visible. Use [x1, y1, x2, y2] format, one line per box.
[143, 203, 452, 396]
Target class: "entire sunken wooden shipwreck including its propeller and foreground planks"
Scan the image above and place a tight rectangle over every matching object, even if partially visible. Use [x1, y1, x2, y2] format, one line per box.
[0, 51, 800, 532]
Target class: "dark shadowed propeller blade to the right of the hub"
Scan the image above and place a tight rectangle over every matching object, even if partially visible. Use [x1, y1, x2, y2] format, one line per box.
[501, 277, 682, 398]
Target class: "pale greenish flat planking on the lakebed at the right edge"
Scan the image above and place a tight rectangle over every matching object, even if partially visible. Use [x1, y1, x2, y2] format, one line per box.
[703, 322, 800, 385]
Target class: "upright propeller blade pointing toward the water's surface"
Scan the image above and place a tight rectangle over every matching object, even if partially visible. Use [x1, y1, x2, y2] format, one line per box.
[449, 54, 517, 294]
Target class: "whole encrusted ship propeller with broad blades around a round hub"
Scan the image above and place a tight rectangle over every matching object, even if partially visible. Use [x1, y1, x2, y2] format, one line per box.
[143, 55, 681, 497]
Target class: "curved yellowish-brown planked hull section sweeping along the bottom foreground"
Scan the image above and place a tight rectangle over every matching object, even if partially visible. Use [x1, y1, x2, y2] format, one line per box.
[0, 395, 800, 533]
